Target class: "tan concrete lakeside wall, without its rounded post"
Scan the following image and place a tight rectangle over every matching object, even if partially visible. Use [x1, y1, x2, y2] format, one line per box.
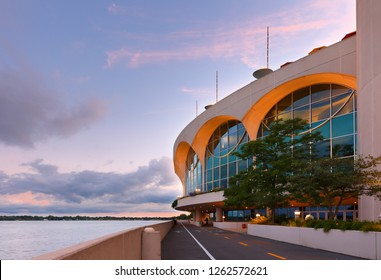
[33, 221, 173, 260]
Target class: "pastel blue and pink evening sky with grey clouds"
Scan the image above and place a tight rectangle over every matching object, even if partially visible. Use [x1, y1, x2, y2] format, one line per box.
[0, 0, 356, 217]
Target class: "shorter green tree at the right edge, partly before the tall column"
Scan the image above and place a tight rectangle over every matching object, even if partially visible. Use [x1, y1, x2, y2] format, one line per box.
[290, 156, 381, 220]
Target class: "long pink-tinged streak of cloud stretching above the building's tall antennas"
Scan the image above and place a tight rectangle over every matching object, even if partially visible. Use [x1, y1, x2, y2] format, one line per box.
[106, 1, 355, 68]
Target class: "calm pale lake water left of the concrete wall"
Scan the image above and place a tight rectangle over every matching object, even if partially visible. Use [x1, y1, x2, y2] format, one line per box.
[0, 220, 164, 260]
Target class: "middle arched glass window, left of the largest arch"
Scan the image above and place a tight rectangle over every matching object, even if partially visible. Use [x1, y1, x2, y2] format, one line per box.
[202, 121, 249, 191]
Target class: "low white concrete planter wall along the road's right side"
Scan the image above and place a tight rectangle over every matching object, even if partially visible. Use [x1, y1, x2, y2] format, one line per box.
[248, 224, 381, 260]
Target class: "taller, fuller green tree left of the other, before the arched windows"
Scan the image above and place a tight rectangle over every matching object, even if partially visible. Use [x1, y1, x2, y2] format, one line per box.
[224, 119, 322, 221]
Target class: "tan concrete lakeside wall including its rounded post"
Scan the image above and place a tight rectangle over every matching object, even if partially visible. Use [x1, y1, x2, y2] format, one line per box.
[33, 221, 173, 260]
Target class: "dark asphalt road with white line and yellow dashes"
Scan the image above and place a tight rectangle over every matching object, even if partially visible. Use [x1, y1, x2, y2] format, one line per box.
[161, 223, 360, 260]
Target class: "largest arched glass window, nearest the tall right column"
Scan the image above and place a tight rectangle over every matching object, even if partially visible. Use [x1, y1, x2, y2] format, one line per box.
[257, 84, 357, 161]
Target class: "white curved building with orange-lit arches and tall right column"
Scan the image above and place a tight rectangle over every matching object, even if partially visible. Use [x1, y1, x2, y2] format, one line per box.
[174, 0, 381, 222]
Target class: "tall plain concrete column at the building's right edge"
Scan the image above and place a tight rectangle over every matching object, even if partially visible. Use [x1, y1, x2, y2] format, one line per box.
[356, 0, 381, 220]
